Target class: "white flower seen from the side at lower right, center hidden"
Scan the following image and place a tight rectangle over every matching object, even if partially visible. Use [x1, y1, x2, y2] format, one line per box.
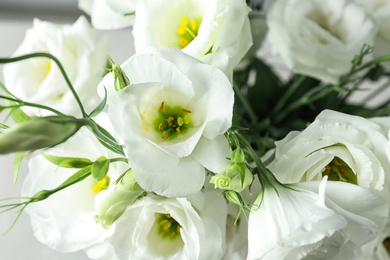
[248, 179, 388, 259]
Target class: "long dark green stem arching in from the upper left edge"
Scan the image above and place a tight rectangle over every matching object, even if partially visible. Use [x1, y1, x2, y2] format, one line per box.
[0, 52, 88, 118]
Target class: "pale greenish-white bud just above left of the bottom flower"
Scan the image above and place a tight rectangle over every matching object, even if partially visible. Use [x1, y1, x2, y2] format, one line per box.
[95, 170, 145, 229]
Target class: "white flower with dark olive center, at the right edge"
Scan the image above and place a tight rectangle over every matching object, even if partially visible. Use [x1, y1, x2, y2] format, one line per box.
[269, 110, 390, 190]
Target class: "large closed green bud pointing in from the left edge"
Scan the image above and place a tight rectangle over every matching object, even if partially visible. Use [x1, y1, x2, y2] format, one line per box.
[0, 116, 83, 154]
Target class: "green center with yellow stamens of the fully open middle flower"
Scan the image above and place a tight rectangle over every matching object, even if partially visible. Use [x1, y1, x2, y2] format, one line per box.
[153, 101, 192, 140]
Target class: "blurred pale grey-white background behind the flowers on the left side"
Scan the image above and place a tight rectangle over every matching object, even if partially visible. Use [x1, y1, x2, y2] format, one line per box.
[0, 0, 134, 260]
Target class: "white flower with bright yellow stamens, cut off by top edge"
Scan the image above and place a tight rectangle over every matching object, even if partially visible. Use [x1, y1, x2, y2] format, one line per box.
[133, 0, 252, 76]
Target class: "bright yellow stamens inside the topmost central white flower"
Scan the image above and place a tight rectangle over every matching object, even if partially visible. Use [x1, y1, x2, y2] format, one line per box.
[177, 17, 202, 48]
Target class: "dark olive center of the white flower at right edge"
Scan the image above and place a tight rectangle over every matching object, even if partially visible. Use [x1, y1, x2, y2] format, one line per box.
[322, 157, 357, 185]
